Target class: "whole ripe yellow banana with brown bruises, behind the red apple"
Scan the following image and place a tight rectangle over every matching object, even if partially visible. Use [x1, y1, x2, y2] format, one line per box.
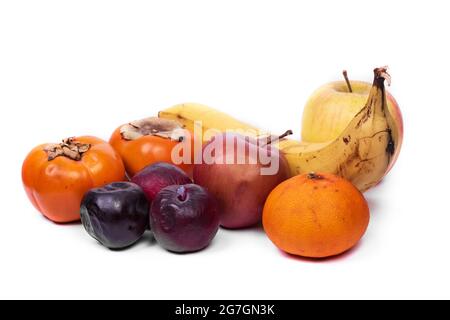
[159, 68, 400, 191]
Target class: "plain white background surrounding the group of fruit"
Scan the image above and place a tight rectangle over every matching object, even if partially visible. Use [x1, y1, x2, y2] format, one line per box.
[0, 0, 450, 299]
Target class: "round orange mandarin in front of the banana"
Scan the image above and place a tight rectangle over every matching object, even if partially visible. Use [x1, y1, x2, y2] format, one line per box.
[263, 173, 369, 258]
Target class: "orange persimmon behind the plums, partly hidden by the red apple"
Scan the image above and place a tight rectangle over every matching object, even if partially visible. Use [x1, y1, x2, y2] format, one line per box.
[109, 117, 193, 178]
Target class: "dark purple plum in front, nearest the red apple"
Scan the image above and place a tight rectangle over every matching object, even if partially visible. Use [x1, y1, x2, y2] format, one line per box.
[150, 184, 220, 253]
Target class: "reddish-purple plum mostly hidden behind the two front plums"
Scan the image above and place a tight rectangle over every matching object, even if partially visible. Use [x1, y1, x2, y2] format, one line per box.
[131, 162, 192, 202]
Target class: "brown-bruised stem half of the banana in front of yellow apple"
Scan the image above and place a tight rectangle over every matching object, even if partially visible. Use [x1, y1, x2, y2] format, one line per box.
[279, 67, 402, 191]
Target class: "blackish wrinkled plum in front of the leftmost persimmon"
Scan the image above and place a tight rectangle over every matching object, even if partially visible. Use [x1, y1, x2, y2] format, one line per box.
[80, 182, 150, 249]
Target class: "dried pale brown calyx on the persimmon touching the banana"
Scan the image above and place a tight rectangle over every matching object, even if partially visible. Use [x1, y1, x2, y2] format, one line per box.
[120, 117, 185, 142]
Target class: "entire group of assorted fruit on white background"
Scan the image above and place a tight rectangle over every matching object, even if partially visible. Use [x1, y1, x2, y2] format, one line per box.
[22, 68, 403, 258]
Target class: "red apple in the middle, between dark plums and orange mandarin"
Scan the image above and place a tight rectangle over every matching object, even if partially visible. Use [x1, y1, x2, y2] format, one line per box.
[194, 133, 289, 229]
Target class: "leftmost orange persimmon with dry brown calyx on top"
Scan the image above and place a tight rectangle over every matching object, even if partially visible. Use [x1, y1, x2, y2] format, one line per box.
[22, 136, 125, 223]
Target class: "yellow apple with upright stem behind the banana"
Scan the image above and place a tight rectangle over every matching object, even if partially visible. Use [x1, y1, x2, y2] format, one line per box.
[302, 81, 403, 171]
